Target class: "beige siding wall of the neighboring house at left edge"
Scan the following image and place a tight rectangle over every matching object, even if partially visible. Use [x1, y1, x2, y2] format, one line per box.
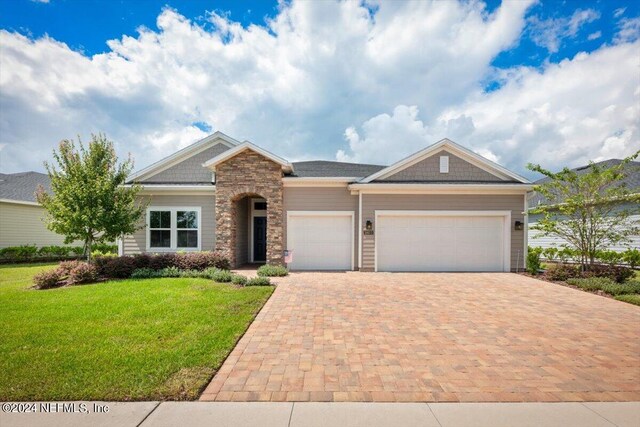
[0, 202, 82, 248]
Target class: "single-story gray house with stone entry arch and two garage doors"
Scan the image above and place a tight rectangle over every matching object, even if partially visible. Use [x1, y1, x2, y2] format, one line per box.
[120, 132, 531, 271]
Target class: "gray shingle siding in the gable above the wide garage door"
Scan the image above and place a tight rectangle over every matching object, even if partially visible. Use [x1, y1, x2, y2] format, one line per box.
[381, 150, 502, 182]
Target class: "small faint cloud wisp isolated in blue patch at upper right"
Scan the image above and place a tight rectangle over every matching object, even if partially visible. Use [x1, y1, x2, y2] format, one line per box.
[528, 9, 600, 53]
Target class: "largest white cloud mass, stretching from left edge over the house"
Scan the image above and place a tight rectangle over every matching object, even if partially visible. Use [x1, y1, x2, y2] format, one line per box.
[0, 1, 530, 174]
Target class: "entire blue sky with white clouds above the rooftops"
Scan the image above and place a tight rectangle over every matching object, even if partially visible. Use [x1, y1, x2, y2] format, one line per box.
[0, 0, 640, 174]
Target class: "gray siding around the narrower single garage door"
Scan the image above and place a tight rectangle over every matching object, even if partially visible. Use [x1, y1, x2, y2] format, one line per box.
[284, 186, 359, 265]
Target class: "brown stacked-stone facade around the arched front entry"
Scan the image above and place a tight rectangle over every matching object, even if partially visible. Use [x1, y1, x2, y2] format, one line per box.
[216, 150, 284, 267]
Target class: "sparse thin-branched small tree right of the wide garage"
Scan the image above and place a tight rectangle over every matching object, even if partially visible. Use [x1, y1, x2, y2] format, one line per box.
[527, 152, 640, 269]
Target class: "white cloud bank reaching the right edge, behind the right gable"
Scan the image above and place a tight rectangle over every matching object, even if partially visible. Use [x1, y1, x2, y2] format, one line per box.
[338, 42, 640, 172]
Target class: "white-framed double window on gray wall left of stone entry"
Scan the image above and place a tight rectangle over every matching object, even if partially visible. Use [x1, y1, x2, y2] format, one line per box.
[147, 207, 200, 252]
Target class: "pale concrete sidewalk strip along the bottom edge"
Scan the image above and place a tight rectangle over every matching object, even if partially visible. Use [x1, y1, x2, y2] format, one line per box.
[0, 402, 640, 427]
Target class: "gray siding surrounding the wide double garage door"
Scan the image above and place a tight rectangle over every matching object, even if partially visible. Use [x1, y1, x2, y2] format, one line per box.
[360, 194, 524, 270]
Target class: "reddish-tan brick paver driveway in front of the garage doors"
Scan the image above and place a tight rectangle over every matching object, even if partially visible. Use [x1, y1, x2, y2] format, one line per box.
[201, 272, 640, 402]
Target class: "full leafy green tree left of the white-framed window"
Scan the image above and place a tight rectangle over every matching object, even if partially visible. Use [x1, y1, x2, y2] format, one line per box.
[36, 134, 144, 260]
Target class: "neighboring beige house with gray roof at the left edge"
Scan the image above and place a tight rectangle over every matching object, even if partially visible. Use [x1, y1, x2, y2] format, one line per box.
[0, 172, 64, 248]
